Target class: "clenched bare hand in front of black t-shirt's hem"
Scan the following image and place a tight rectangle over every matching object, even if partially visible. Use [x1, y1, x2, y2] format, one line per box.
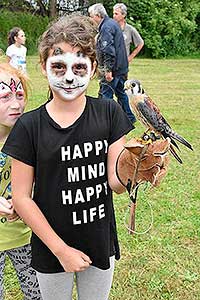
[57, 245, 92, 272]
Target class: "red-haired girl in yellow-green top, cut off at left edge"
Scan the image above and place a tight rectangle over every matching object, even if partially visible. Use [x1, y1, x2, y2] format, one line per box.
[0, 64, 41, 300]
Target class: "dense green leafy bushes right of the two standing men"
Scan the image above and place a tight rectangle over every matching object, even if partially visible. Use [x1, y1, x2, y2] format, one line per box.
[104, 0, 200, 58]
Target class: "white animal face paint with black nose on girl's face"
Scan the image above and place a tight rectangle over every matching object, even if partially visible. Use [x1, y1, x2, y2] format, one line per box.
[46, 52, 92, 100]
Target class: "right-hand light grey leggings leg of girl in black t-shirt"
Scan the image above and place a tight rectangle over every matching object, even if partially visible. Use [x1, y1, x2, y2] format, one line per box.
[76, 256, 115, 300]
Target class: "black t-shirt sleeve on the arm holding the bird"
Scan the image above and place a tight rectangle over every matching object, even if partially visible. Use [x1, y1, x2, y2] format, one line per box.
[109, 100, 133, 145]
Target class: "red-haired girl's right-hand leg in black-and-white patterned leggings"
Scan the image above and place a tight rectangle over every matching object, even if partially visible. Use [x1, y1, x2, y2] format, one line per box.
[7, 245, 42, 300]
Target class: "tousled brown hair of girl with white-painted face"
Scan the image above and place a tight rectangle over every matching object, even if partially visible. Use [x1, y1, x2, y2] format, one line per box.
[38, 14, 97, 64]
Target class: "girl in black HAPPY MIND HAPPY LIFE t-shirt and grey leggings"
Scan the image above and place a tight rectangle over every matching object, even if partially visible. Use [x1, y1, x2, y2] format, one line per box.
[3, 15, 132, 300]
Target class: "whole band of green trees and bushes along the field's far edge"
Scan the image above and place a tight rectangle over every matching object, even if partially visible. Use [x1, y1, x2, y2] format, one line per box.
[0, 0, 200, 58]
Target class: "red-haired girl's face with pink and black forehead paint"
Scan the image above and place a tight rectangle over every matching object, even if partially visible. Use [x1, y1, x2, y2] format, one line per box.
[0, 72, 25, 127]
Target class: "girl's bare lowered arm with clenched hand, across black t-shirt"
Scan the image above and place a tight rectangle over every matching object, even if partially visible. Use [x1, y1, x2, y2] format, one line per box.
[11, 159, 91, 272]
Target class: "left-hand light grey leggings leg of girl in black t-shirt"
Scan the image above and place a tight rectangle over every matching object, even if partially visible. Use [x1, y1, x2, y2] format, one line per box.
[36, 271, 74, 300]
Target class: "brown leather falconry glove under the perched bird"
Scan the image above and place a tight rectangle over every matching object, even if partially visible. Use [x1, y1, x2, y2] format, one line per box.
[116, 138, 170, 189]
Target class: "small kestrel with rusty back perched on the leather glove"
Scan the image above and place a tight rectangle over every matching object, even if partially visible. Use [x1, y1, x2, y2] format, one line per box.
[125, 79, 193, 163]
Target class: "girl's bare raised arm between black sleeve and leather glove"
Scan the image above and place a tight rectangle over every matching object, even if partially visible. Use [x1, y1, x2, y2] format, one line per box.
[108, 136, 126, 194]
